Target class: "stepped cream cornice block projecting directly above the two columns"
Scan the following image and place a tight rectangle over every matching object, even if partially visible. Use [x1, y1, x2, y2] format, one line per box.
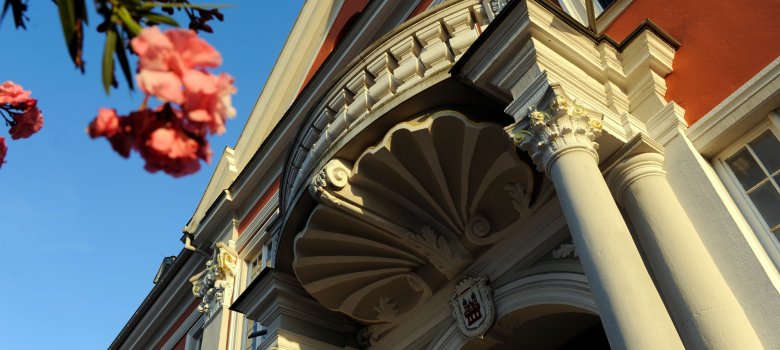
[452, 0, 678, 154]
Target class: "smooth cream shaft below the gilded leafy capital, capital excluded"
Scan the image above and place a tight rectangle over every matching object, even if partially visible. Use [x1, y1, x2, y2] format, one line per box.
[549, 149, 683, 349]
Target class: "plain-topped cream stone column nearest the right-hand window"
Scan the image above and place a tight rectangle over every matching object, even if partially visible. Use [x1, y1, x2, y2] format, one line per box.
[607, 135, 763, 349]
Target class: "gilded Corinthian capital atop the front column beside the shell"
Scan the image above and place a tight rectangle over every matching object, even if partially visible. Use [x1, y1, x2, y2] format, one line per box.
[508, 95, 603, 173]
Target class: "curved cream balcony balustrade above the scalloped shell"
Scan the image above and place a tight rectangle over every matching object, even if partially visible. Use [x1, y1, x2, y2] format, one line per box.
[283, 0, 490, 211]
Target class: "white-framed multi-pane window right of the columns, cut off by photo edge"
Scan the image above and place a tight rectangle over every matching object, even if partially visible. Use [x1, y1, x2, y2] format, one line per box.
[715, 112, 780, 264]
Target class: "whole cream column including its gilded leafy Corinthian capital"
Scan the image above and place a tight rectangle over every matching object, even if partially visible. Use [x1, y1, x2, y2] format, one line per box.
[511, 96, 683, 349]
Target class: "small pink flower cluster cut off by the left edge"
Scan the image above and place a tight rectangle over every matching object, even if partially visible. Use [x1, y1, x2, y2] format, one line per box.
[0, 81, 43, 167]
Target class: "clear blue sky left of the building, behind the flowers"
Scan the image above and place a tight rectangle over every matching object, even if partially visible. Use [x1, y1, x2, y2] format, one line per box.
[0, 0, 303, 350]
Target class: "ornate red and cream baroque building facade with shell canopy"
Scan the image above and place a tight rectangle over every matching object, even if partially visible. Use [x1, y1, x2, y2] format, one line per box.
[110, 0, 780, 350]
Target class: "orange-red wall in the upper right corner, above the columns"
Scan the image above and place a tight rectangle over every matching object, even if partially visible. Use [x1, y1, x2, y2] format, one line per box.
[606, 0, 780, 125]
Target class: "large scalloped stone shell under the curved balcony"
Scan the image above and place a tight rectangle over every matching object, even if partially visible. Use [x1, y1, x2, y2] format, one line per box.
[293, 111, 535, 323]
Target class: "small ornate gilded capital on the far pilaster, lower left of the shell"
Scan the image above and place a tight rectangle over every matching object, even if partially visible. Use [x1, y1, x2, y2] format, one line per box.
[190, 241, 237, 320]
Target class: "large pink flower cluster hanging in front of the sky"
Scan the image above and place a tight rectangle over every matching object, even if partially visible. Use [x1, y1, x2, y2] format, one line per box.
[87, 27, 236, 177]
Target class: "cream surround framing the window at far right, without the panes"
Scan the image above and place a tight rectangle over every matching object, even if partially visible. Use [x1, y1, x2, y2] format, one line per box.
[712, 111, 780, 269]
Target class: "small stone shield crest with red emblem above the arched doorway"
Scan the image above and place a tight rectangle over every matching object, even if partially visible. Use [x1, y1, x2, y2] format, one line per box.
[450, 277, 495, 338]
